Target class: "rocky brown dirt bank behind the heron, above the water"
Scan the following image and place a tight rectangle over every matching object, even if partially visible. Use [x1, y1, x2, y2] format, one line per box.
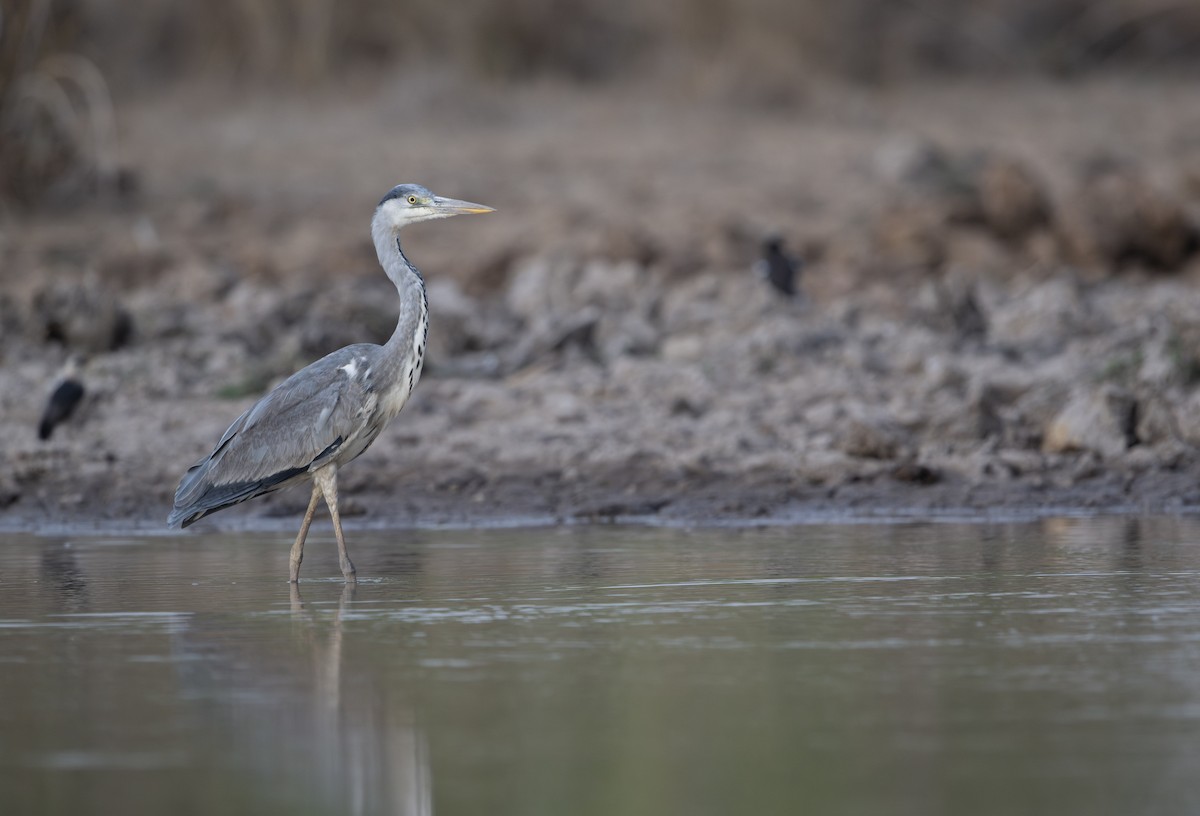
[7, 79, 1200, 526]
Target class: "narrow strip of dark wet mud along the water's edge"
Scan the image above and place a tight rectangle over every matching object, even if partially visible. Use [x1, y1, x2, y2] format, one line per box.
[0, 448, 1200, 534]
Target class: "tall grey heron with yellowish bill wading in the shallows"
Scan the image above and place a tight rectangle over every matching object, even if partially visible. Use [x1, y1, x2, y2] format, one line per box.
[167, 184, 492, 583]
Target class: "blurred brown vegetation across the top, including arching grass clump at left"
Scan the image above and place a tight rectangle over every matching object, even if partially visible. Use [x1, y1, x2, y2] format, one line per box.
[7, 0, 1200, 204]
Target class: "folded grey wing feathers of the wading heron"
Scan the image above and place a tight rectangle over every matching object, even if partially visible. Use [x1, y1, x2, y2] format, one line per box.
[167, 346, 372, 527]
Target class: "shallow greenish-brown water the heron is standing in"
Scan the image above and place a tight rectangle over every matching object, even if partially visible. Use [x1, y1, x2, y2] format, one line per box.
[0, 518, 1200, 816]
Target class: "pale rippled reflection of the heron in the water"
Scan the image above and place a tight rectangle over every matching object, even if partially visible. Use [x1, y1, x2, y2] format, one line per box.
[182, 584, 433, 816]
